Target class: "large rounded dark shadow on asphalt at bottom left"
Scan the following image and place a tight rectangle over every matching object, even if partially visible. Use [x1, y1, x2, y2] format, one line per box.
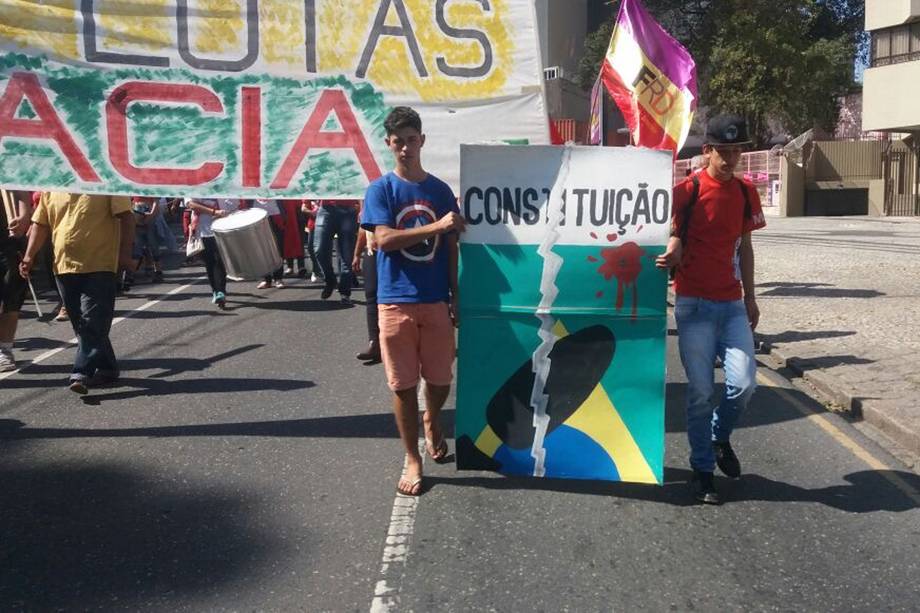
[0, 463, 289, 611]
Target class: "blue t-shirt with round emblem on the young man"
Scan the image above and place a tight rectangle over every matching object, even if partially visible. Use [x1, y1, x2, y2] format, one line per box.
[361, 172, 460, 304]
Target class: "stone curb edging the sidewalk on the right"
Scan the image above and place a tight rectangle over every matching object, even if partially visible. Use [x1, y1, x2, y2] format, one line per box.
[755, 335, 920, 455]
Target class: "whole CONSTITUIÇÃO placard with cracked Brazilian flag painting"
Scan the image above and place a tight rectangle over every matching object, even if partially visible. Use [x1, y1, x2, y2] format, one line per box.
[456, 146, 672, 483]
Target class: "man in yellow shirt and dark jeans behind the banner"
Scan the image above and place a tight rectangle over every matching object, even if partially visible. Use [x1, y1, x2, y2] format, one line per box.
[19, 192, 134, 394]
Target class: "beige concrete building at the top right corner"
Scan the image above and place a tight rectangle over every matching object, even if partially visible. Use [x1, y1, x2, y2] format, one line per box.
[862, 0, 920, 215]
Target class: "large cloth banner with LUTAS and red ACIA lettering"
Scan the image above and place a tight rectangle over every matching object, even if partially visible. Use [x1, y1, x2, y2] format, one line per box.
[0, 0, 549, 197]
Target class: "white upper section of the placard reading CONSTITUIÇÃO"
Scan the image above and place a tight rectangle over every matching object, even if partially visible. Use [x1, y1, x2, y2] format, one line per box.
[460, 145, 672, 245]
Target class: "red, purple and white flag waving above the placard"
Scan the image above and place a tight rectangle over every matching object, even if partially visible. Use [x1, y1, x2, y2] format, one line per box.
[601, 0, 697, 155]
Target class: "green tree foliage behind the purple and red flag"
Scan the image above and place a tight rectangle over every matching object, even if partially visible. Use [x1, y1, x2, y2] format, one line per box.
[577, 0, 866, 144]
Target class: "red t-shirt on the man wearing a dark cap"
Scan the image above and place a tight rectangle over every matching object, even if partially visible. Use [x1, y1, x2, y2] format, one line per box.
[674, 172, 767, 300]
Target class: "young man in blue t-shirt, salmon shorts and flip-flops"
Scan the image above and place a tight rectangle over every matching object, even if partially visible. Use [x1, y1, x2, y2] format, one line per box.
[361, 107, 465, 496]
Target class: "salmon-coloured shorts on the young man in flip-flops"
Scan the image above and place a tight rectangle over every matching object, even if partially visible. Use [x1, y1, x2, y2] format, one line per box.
[377, 302, 456, 392]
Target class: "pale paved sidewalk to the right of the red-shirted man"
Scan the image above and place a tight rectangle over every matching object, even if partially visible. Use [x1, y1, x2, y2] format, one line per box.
[754, 217, 920, 456]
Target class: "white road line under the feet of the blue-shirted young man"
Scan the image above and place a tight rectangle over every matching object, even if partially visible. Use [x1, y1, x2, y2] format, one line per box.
[371, 439, 425, 613]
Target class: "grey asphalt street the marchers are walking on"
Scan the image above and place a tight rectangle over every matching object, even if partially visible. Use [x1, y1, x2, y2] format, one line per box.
[0, 268, 920, 611]
